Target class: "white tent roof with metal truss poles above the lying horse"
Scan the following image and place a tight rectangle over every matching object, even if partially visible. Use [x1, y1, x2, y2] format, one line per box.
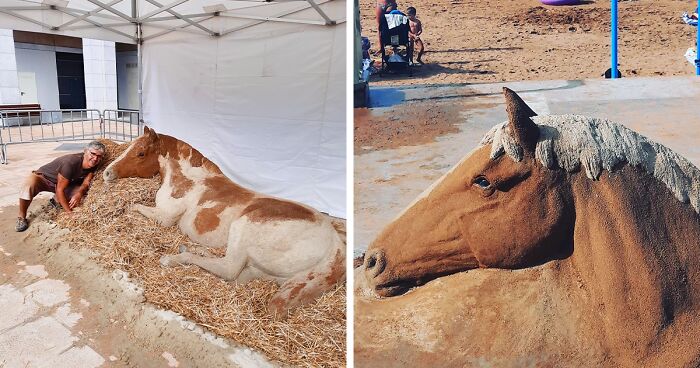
[0, 0, 345, 43]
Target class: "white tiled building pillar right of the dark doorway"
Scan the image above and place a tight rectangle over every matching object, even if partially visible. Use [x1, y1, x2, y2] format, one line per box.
[83, 38, 117, 111]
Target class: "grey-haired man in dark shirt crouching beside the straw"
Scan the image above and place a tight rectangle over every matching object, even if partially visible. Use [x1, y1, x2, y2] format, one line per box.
[15, 141, 106, 231]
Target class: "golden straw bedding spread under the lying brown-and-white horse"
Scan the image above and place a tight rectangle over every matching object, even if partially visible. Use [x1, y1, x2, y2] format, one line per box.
[53, 141, 346, 367]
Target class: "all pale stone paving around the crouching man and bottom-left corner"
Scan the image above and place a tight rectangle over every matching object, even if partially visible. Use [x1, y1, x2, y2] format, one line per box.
[0, 143, 110, 368]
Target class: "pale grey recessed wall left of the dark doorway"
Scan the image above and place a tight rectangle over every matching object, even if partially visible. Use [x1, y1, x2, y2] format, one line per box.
[15, 43, 60, 110]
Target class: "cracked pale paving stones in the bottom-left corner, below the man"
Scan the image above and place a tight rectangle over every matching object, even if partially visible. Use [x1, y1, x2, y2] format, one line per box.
[0, 247, 106, 368]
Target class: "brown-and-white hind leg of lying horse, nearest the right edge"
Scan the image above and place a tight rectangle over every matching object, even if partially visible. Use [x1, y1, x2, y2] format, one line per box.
[267, 243, 345, 318]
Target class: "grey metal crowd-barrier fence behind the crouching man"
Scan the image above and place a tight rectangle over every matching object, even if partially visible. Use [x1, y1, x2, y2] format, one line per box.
[0, 109, 142, 164]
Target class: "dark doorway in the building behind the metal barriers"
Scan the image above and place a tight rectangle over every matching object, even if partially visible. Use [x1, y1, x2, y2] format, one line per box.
[56, 52, 86, 109]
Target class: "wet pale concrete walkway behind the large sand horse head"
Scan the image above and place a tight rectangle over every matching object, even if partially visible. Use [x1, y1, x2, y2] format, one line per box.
[354, 77, 700, 254]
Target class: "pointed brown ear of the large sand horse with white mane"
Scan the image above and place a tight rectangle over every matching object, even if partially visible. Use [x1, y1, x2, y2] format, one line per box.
[503, 87, 540, 152]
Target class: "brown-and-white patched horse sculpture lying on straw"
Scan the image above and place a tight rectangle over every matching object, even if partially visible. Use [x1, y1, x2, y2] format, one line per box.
[103, 127, 345, 313]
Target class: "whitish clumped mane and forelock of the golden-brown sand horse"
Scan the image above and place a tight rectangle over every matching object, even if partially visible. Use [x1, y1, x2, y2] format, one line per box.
[480, 115, 700, 213]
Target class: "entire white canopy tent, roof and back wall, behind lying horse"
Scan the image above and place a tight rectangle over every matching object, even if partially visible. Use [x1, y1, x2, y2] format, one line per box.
[0, 0, 346, 217]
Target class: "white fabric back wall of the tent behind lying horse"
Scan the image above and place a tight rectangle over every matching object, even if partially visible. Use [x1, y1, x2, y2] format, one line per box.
[143, 12, 346, 217]
